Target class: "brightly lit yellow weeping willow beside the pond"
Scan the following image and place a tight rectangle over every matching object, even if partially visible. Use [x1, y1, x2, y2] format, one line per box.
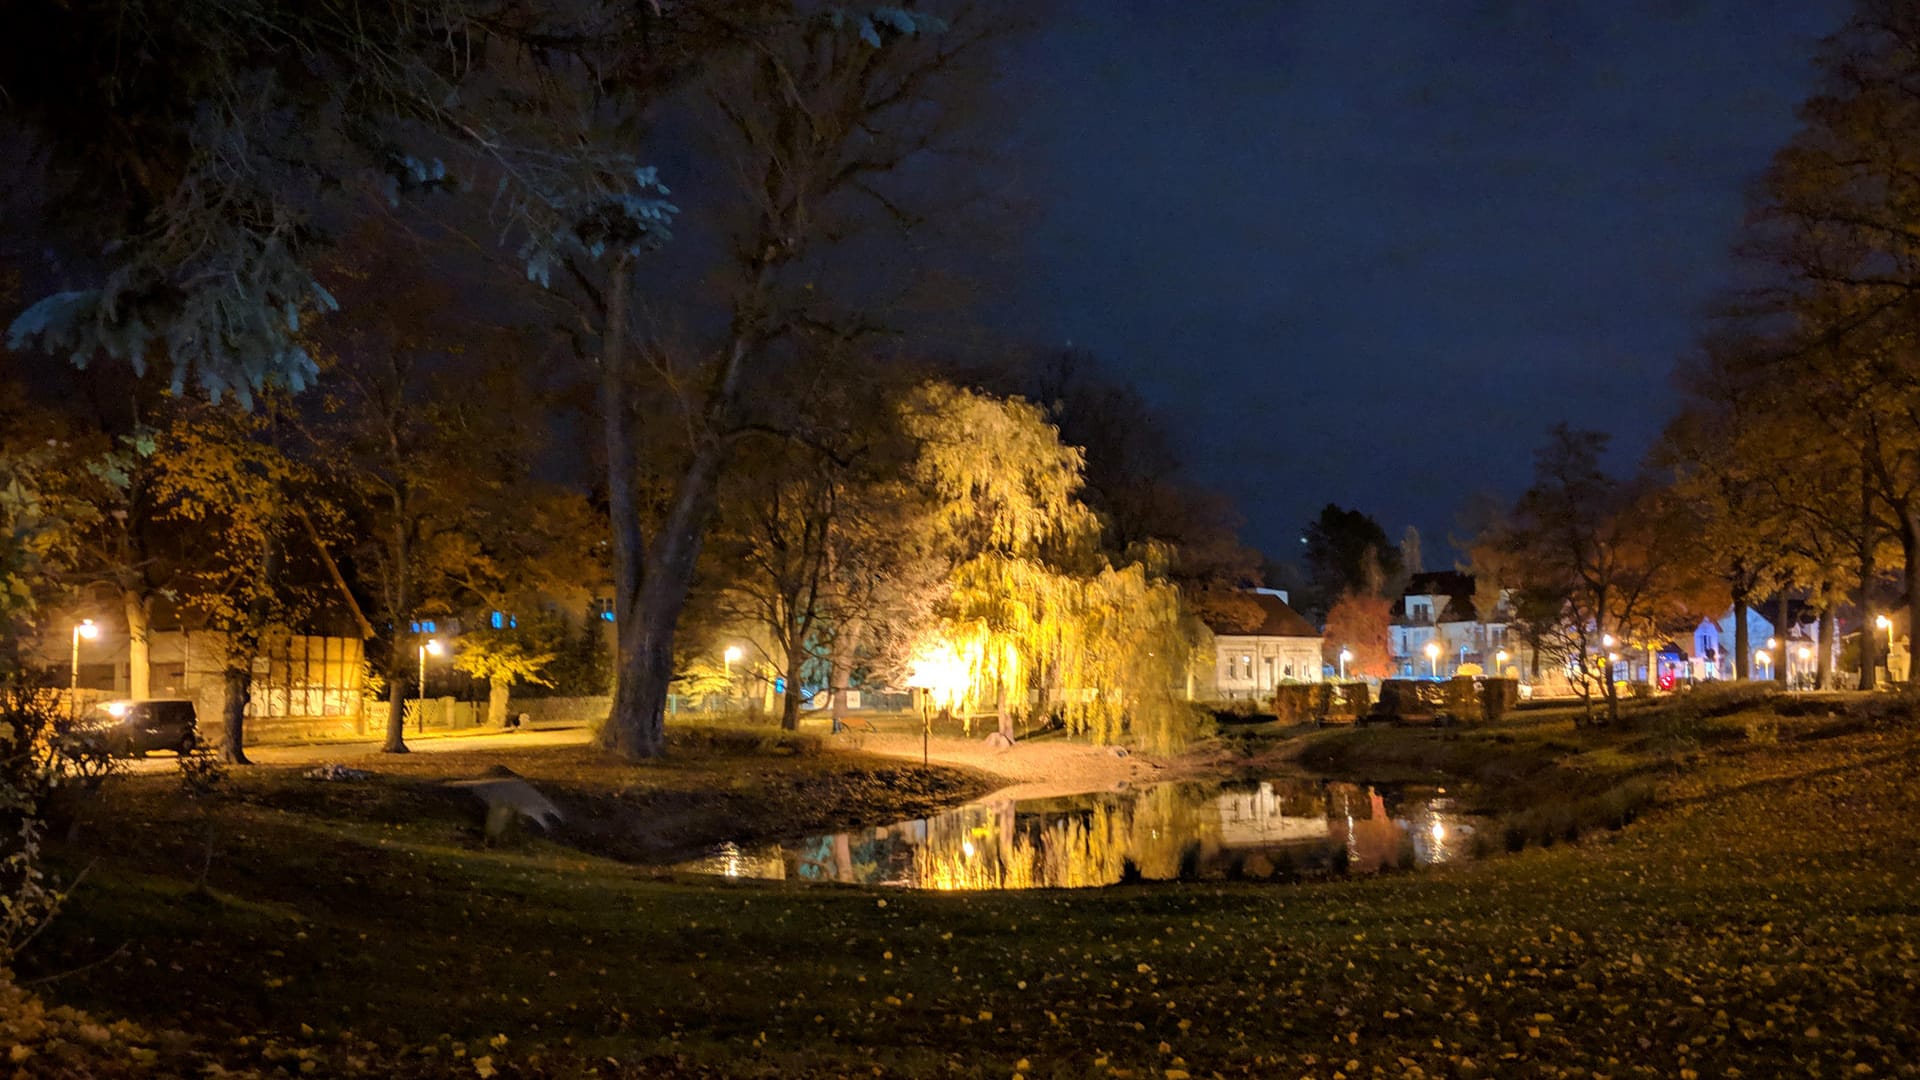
[908, 384, 1192, 748]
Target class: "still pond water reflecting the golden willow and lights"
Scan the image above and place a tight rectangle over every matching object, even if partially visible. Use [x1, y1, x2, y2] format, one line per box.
[674, 778, 1482, 890]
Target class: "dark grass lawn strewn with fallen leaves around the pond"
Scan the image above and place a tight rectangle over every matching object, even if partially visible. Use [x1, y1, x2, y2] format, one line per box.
[15, 687, 1920, 1080]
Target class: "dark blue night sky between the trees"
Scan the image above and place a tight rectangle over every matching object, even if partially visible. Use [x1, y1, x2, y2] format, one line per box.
[995, 0, 1845, 565]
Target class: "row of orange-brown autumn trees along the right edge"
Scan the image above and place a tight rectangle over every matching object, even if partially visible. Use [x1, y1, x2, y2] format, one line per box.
[1471, 0, 1920, 715]
